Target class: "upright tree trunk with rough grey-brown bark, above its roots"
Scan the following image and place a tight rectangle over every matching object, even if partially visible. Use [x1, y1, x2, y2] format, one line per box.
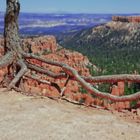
[4, 0, 21, 59]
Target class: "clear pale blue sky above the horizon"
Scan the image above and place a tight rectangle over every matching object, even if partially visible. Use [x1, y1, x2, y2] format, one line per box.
[0, 0, 140, 13]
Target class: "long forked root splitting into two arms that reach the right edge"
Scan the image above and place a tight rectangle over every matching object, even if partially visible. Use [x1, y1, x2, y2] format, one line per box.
[21, 54, 140, 102]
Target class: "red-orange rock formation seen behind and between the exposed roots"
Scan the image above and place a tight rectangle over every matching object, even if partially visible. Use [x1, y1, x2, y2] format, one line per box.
[0, 36, 130, 109]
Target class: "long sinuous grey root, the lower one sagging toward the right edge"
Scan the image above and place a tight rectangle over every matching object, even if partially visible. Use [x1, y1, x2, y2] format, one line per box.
[24, 54, 140, 102]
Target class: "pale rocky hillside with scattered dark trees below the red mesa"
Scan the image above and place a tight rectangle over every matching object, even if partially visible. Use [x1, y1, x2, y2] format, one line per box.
[62, 21, 140, 53]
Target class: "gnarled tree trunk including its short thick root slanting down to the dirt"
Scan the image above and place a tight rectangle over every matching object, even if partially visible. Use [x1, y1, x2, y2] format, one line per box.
[3, 0, 27, 89]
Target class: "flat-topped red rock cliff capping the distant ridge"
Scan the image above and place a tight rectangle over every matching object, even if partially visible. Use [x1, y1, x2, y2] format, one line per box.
[112, 16, 140, 23]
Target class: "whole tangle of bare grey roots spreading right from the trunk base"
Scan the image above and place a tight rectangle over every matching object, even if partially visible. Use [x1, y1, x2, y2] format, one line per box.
[1, 53, 140, 102]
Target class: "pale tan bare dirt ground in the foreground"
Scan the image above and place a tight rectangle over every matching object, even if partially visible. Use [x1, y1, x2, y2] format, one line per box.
[0, 89, 140, 140]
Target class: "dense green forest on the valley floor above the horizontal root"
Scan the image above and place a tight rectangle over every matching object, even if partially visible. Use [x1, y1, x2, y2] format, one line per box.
[63, 45, 140, 75]
